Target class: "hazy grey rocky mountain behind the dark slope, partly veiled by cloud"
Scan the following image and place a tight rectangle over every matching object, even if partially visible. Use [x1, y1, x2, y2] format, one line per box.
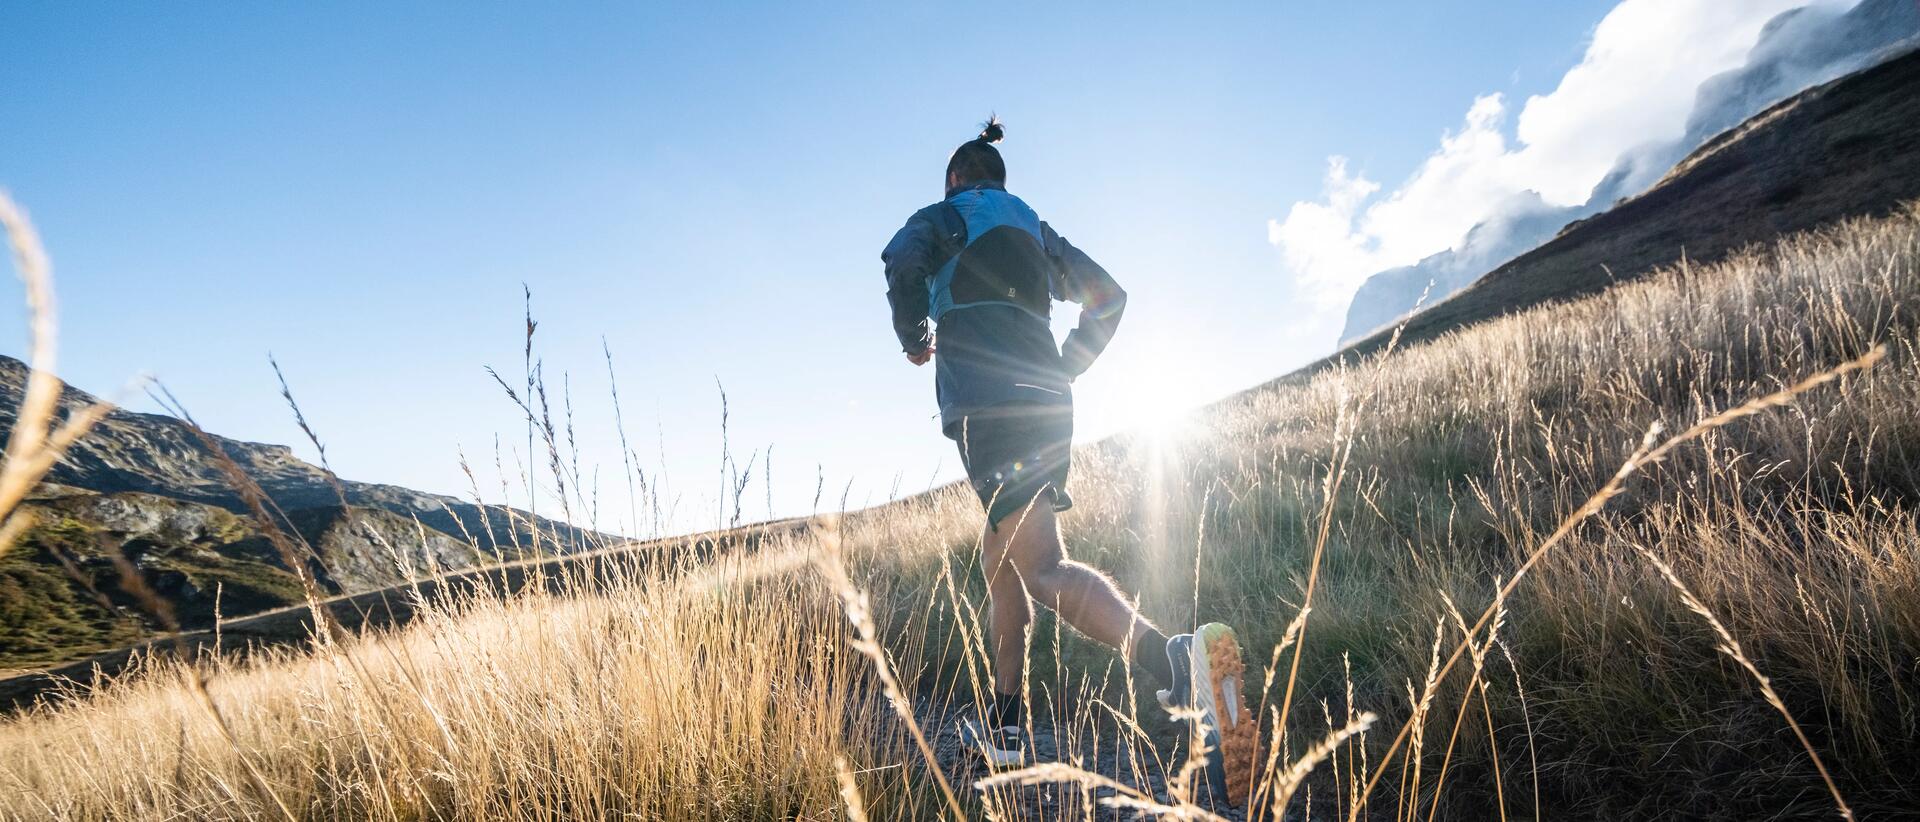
[1340, 0, 1920, 344]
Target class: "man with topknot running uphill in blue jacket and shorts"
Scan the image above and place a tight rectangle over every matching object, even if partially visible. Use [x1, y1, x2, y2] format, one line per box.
[881, 119, 1238, 791]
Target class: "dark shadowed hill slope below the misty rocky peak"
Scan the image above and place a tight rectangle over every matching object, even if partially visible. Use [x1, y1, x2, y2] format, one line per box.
[1328, 37, 1920, 366]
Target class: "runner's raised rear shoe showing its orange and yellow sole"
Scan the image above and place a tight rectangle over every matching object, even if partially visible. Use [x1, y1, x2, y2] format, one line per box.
[1156, 622, 1260, 805]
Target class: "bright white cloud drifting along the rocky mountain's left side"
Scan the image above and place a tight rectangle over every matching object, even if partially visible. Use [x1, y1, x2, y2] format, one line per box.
[1267, 0, 1809, 309]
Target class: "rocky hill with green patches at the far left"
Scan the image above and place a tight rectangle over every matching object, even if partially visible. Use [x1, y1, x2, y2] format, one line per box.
[0, 357, 618, 668]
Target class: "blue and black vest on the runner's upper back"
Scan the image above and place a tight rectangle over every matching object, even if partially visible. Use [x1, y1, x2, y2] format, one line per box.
[927, 188, 1056, 323]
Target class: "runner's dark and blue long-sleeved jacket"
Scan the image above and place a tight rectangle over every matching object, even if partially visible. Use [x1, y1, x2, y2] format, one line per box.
[879, 182, 1127, 432]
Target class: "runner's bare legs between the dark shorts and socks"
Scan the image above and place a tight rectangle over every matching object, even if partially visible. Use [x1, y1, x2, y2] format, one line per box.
[981, 494, 1158, 693]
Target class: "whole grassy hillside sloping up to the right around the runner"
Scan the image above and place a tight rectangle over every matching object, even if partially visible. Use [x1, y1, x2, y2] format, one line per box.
[0, 207, 1920, 820]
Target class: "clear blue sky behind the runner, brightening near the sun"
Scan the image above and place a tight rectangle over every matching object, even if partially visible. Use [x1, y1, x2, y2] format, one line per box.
[0, 2, 1674, 524]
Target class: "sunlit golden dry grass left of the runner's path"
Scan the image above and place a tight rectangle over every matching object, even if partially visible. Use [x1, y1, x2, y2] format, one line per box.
[0, 541, 910, 820]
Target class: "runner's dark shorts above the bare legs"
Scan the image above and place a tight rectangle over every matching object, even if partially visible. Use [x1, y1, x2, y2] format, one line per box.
[947, 403, 1073, 528]
